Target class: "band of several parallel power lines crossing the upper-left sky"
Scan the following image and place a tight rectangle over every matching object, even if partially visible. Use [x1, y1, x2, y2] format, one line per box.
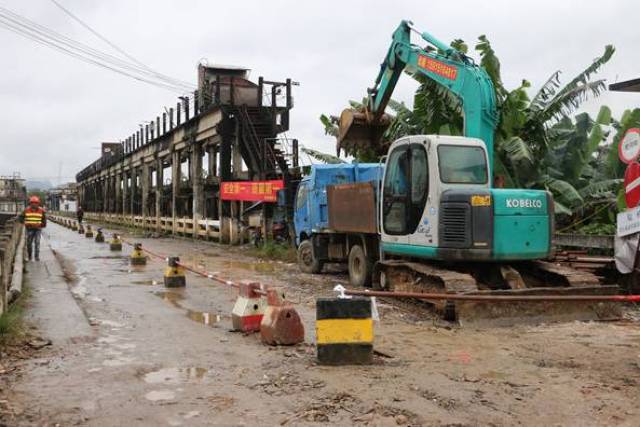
[0, 7, 193, 93]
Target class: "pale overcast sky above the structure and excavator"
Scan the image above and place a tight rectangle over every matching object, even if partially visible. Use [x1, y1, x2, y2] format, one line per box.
[0, 0, 640, 184]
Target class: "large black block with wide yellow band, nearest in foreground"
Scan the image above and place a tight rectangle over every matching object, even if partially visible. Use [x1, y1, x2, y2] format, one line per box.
[316, 298, 373, 365]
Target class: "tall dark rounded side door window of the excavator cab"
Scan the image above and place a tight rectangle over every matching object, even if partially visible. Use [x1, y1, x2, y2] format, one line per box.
[382, 144, 429, 235]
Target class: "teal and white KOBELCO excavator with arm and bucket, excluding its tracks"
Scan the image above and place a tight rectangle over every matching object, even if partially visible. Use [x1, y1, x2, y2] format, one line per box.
[338, 21, 553, 268]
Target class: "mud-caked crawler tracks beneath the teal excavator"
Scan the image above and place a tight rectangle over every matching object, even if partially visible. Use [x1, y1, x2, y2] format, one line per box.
[374, 260, 622, 326]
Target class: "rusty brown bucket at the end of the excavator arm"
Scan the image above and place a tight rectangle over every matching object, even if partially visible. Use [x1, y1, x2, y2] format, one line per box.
[337, 108, 391, 155]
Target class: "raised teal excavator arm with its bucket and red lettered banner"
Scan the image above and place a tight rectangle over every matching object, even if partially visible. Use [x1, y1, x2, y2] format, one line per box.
[338, 21, 498, 171]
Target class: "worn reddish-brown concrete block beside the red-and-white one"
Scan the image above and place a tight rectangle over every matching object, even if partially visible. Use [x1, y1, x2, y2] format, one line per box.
[260, 288, 304, 345]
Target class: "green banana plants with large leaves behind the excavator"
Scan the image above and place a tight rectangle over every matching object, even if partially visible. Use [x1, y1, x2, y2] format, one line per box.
[318, 36, 640, 234]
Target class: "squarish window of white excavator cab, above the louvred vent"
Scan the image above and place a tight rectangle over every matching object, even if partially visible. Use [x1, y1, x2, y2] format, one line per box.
[438, 145, 487, 184]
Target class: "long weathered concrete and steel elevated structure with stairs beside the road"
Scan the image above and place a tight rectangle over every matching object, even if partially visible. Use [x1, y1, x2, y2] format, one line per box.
[76, 65, 300, 244]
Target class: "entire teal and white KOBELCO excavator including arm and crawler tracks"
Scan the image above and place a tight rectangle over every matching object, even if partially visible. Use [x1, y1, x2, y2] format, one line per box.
[320, 21, 611, 322]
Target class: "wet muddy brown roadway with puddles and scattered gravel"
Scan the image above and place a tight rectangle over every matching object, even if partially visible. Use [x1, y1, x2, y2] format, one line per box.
[0, 224, 640, 426]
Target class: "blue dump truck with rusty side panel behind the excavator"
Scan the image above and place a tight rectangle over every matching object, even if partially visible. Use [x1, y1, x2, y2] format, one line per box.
[294, 163, 384, 286]
